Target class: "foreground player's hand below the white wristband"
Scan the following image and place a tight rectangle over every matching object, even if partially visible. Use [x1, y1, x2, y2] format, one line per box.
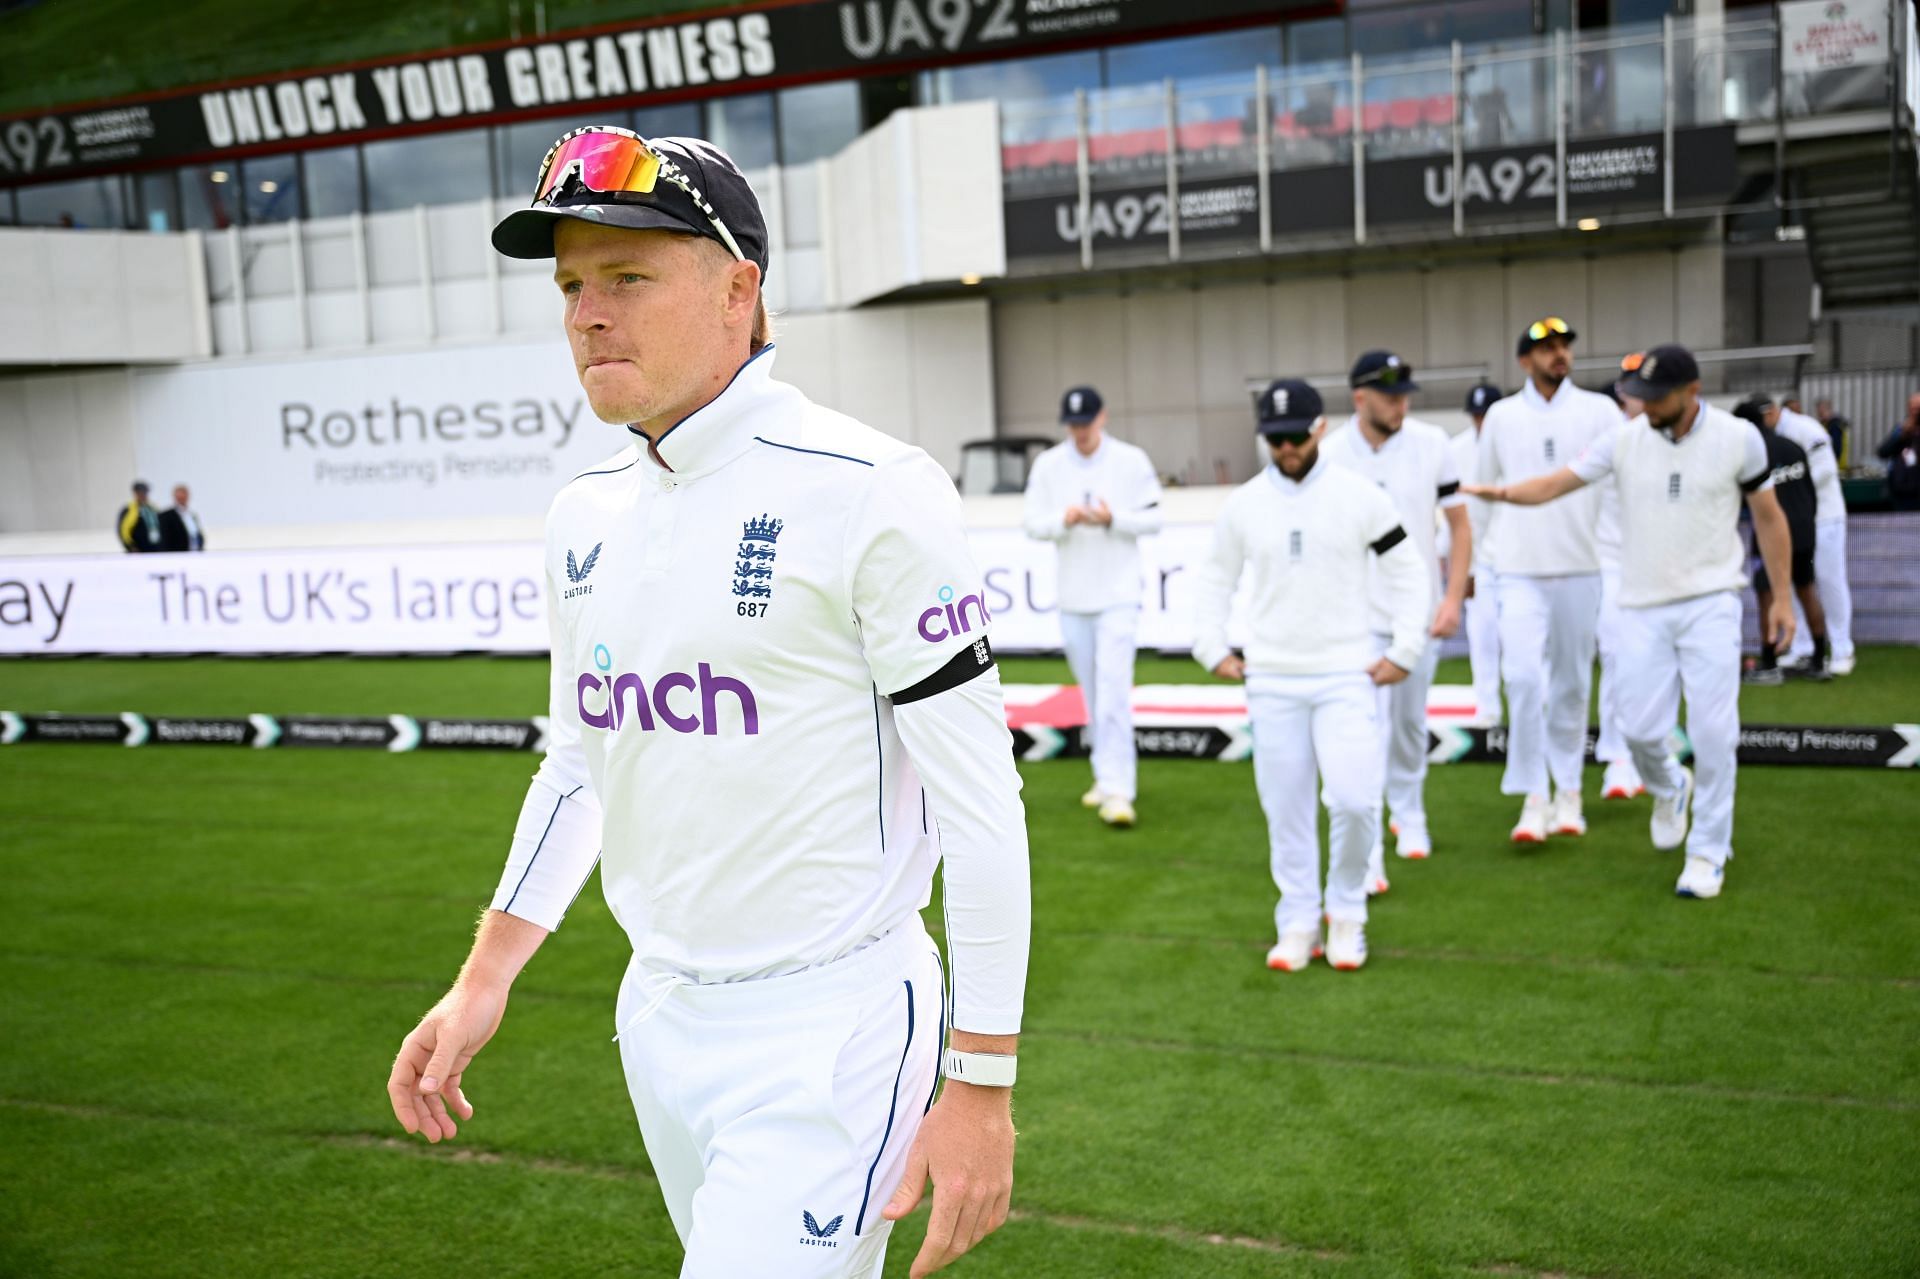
[879, 1081, 1014, 1279]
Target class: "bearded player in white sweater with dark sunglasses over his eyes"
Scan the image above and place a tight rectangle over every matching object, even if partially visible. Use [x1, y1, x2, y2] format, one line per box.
[1194, 378, 1432, 972]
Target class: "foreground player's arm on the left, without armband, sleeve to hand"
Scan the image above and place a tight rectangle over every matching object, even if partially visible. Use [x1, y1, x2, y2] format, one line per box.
[386, 564, 601, 1143]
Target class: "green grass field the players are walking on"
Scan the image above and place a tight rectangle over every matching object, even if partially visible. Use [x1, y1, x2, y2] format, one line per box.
[0, 651, 1920, 1279]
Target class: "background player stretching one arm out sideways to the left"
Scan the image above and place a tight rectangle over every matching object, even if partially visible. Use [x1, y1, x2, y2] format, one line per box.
[1482, 346, 1793, 897]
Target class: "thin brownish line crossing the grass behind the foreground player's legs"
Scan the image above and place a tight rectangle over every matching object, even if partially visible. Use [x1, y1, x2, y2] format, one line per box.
[0, 1097, 1592, 1279]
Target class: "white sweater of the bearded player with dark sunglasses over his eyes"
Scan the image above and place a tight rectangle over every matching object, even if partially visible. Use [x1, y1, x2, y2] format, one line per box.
[1194, 457, 1432, 676]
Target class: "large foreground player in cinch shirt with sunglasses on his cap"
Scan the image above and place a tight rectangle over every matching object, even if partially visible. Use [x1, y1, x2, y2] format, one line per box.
[388, 127, 1029, 1279]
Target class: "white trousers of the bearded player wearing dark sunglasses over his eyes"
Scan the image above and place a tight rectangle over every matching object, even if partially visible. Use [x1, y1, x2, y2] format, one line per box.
[1246, 670, 1382, 933]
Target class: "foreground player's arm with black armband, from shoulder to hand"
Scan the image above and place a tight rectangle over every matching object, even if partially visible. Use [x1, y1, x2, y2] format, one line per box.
[849, 453, 1033, 1279]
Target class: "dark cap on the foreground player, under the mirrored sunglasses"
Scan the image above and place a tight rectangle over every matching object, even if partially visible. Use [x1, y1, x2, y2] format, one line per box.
[493, 127, 768, 284]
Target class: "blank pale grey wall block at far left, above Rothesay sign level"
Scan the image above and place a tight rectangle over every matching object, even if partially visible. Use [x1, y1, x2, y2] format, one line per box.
[0, 229, 213, 367]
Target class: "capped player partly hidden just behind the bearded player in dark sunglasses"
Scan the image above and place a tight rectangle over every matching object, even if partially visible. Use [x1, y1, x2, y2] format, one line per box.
[1321, 351, 1473, 895]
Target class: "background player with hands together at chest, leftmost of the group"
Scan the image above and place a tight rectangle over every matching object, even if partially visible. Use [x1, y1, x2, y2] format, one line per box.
[1025, 386, 1160, 826]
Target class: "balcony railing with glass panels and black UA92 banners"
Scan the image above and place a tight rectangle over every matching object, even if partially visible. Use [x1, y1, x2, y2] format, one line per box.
[1000, 4, 1920, 269]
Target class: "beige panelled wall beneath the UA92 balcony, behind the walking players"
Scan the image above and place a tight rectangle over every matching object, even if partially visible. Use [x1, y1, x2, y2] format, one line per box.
[993, 244, 1722, 484]
